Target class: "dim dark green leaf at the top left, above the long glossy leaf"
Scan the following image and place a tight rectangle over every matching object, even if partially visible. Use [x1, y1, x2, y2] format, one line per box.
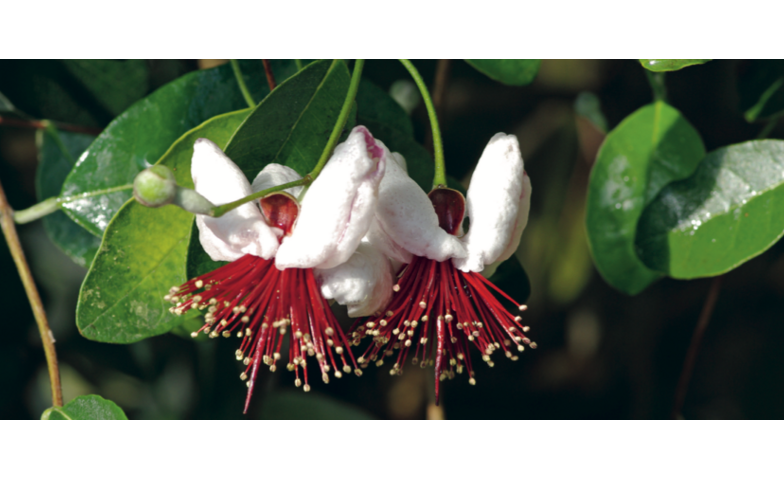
[61, 59, 150, 116]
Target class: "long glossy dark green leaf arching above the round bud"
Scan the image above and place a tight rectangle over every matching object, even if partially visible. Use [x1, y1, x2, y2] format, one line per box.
[62, 61, 294, 236]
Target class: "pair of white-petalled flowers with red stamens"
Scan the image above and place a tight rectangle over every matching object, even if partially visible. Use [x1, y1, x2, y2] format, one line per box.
[166, 126, 536, 410]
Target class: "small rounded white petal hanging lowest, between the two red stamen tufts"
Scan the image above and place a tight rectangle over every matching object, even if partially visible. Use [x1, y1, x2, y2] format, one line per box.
[315, 241, 393, 318]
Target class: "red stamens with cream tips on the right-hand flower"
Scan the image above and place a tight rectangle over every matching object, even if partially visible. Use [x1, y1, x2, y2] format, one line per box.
[351, 256, 536, 404]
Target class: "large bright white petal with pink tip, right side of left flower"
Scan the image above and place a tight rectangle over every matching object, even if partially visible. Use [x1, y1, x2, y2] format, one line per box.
[275, 126, 386, 269]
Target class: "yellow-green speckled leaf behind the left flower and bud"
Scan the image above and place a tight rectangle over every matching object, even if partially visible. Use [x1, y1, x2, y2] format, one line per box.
[76, 109, 250, 343]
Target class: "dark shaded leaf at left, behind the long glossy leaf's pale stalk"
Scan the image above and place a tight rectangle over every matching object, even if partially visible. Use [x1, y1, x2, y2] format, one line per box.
[35, 130, 101, 268]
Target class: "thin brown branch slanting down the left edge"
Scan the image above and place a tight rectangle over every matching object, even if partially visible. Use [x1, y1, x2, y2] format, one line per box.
[0, 178, 63, 406]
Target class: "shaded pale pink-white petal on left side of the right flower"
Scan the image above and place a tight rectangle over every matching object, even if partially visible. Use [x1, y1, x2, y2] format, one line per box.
[371, 148, 466, 262]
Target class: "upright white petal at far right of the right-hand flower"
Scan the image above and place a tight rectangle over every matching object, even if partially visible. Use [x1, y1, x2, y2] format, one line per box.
[454, 133, 531, 272]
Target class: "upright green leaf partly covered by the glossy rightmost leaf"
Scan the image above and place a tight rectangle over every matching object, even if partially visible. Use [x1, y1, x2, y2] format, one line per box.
[586, 102, 705, 294]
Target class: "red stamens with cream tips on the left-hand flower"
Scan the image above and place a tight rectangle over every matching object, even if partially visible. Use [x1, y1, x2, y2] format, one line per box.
[170, 255, 362, 412]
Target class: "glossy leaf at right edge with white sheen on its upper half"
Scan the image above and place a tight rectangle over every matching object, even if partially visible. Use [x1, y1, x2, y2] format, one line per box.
[637, 140, 784, 279]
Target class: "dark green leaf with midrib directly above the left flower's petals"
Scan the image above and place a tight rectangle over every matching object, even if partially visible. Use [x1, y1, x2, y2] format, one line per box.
[187, 60, 354, 278]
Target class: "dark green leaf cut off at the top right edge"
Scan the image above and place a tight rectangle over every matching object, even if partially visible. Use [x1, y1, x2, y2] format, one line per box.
[738, 60, 784, 121]
